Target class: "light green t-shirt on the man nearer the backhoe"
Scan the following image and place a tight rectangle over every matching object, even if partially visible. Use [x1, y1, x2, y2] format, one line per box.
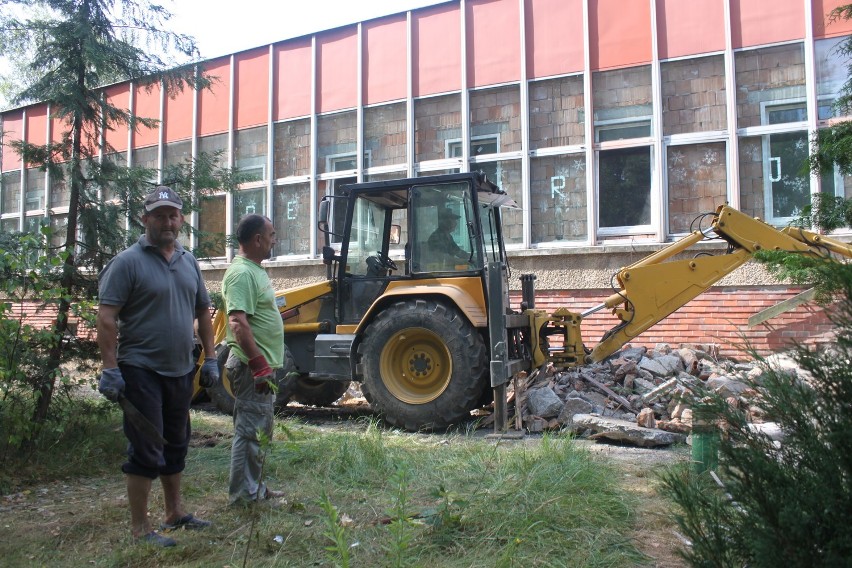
[222, 256, 284, 369]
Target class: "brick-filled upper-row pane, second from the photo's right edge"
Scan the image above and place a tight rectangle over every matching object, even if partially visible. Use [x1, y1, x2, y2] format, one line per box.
[734, 43, 807, 128]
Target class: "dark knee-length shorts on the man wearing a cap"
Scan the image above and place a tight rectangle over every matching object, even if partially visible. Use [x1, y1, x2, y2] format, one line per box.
[119, 365, 195, 479]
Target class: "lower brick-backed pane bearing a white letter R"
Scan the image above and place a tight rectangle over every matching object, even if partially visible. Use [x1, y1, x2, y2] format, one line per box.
[530, 154, 589, 244]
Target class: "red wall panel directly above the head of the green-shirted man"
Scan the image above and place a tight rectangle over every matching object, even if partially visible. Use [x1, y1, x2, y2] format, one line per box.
[234, 47, 269, 129]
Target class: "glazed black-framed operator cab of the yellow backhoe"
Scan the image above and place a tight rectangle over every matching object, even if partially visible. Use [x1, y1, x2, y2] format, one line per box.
[319, 172, 517, 324]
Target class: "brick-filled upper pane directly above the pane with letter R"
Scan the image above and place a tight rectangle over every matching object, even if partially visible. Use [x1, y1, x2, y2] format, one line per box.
[529, 76, 585, 150]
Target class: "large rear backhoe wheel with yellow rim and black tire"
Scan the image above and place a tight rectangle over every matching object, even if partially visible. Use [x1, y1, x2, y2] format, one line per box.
[358, 300, 488, 431]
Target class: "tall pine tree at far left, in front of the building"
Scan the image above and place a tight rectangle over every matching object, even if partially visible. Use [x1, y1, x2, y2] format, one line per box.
[0, 0, 234, 424]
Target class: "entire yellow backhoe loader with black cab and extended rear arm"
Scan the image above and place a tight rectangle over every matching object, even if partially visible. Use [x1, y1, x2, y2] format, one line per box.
[193, 173, 852, 431]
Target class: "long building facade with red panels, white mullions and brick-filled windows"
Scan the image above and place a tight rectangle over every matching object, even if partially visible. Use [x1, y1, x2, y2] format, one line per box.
[0, 0, 852, 356]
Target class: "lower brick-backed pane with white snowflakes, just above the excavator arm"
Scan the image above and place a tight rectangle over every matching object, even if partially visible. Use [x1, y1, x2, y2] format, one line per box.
[666, 142, 728, 234]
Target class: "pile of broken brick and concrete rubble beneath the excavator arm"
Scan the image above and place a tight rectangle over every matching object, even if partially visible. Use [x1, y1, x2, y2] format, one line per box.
[514, 344, 792, 447]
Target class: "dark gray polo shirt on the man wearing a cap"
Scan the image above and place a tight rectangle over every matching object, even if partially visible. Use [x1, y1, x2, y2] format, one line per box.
[98, 235, 210, 377]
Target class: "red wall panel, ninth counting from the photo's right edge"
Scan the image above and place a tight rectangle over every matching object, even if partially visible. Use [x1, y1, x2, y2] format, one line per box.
[317, 26, 358, 113]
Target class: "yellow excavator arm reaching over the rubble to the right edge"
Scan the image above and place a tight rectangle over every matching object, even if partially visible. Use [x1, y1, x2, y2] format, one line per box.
[528, 205, 852, 368]
